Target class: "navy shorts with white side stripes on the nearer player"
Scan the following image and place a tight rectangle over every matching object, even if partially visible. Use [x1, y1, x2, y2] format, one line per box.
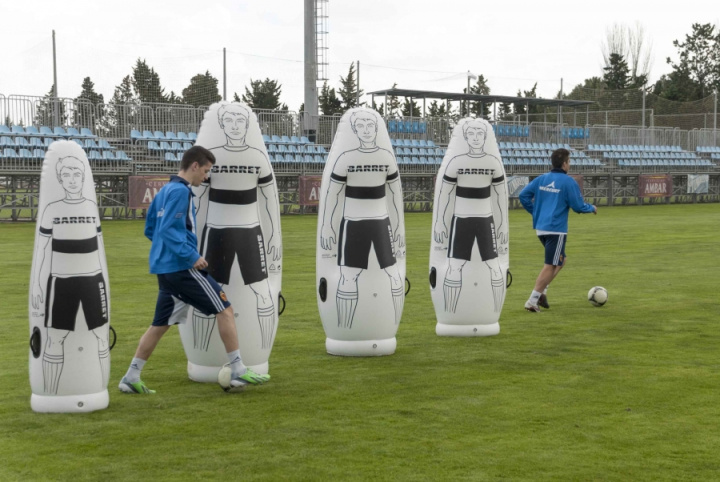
[152, 269, 230, 326]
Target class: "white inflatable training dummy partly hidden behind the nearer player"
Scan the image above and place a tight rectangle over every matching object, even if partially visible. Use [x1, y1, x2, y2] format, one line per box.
[180, 102, 282, 382]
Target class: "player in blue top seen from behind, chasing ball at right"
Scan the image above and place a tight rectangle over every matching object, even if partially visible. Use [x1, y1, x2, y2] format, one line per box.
[520, 149, 597, 313]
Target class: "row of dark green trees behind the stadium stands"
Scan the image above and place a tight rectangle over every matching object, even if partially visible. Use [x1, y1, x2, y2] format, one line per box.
[19, 23, 720, 129]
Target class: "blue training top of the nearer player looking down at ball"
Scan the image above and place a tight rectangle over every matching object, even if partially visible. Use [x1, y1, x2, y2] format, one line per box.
[145, 176, 200, 274]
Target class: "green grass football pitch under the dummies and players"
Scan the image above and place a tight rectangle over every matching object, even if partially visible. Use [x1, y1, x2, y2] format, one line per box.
[0, 204, 720, 481]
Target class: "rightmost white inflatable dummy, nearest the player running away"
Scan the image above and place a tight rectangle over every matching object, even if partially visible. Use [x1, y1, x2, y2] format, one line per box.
[430, 118, 510, 336]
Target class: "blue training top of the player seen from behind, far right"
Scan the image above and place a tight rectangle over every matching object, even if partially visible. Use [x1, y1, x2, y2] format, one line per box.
[520, 169, 595, 233]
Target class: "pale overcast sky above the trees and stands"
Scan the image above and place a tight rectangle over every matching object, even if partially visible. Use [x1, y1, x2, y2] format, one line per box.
[0, 0, 720, 110]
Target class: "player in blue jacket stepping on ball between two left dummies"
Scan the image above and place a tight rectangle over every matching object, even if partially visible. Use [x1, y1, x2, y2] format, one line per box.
[118, 146, 270, 394]
